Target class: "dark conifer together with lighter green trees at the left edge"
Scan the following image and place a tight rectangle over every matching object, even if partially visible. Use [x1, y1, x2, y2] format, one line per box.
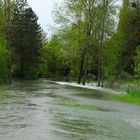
[0, 0, 42, 83]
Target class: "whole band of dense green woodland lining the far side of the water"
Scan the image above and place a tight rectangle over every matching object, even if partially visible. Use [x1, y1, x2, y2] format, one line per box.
[0, 0, 140, 86]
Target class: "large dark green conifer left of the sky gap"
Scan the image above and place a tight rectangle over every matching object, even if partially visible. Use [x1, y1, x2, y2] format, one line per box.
[11, 3, 42, 79]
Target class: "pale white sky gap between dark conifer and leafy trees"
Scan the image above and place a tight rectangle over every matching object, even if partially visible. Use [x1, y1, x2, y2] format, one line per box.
[27, 0, 63, 34]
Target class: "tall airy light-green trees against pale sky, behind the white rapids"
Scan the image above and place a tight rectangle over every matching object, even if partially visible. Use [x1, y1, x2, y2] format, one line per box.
[48, 0, 117, 83]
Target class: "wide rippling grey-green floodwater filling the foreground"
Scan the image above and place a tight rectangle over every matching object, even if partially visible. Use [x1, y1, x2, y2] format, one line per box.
[0, 80, 140, 140]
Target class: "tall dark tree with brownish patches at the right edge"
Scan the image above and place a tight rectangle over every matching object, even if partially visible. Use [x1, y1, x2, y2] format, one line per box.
[118, 0, 140, 75]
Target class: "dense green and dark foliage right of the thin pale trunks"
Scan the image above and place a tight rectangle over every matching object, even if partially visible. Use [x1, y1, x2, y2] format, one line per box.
[104, 0, 140, 79]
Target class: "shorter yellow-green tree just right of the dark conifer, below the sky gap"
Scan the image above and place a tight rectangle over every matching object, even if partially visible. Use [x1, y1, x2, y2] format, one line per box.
[41, 35, 70, 79]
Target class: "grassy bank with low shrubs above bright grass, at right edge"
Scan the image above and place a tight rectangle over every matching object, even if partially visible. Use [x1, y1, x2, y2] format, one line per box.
[105, 76, 140, 105]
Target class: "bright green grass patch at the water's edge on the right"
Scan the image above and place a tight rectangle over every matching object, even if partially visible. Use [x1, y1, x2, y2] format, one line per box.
[111, 90, 140, 105]
